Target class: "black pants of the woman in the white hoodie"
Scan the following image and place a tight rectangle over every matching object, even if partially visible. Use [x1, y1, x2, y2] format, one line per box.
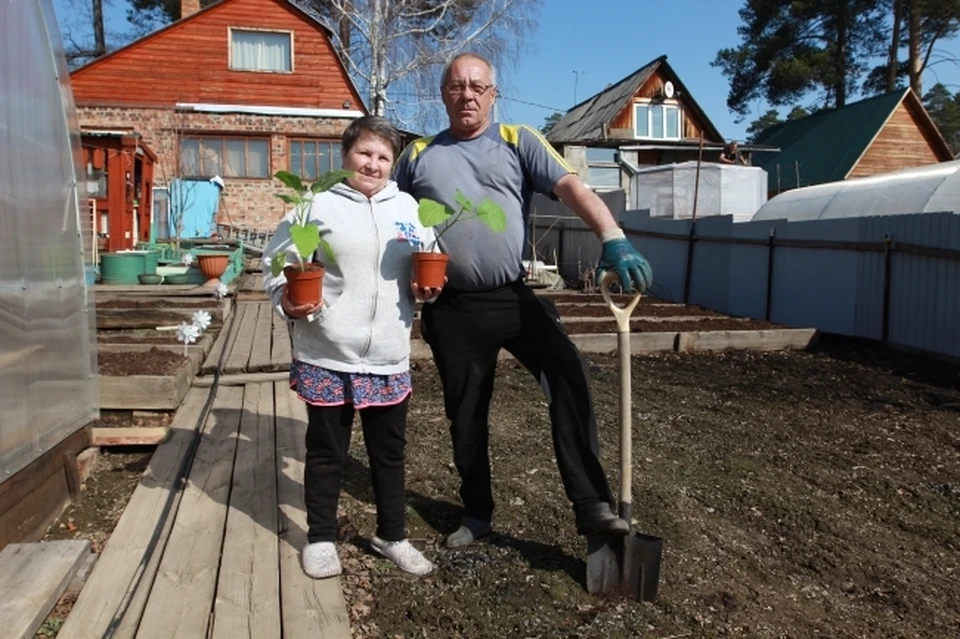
[303, 397, 409, 544]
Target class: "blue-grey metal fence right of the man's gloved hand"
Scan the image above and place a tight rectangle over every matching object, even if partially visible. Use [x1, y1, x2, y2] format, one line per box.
[621, 211, 960, 357]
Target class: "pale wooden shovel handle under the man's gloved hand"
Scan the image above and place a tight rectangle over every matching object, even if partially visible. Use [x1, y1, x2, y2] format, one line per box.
[600, 271, 640, 524]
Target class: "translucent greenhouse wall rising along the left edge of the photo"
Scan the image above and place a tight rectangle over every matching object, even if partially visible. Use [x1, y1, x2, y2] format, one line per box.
[0, 0, 98, 482]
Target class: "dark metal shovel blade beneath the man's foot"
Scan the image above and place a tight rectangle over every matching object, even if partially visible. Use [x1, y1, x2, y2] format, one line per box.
[587, 532, 663, 601]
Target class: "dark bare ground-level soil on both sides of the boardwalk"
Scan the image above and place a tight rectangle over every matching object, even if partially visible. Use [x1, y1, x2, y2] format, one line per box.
[37, 337, 960, 639]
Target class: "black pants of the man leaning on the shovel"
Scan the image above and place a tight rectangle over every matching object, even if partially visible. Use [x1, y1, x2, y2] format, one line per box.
[421, 282, 613, 521]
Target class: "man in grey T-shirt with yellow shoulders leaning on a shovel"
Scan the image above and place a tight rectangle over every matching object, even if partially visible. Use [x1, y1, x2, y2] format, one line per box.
[394, 54, 652, 548]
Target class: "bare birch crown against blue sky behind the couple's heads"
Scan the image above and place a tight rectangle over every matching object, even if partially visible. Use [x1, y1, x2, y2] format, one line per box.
[310, 0, 541, 124]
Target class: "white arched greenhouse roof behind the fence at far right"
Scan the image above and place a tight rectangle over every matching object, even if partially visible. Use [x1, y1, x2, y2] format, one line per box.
[753, 160, 960, 221]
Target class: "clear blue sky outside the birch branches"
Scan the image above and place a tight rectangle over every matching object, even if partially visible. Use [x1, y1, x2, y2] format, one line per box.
[54, 0, 960, 140]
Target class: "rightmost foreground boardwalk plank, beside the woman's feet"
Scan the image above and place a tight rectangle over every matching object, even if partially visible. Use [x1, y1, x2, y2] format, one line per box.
[273, 383, 350, 639]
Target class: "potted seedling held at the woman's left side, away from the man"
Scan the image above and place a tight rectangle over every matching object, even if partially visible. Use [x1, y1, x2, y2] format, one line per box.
[270, 170, 353, 306]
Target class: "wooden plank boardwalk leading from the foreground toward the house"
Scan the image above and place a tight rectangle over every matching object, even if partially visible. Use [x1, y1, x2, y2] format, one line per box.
[57, 282, 350, 639]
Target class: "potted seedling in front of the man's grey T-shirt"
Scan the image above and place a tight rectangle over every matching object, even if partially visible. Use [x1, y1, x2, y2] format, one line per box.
[413, 189, 507, 288]
